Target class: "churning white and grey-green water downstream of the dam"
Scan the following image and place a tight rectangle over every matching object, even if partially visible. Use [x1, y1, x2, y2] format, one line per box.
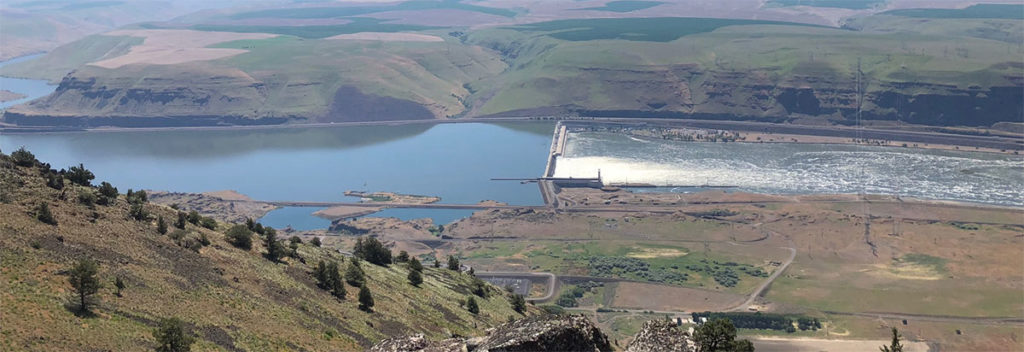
[555, 132, 1024, 206]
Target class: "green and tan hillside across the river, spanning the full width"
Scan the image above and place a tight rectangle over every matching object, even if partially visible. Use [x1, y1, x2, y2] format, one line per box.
[3, 7, 1024, 126]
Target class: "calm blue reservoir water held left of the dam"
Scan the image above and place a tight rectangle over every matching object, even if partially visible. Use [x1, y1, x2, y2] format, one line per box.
[0, 123, 554, 229]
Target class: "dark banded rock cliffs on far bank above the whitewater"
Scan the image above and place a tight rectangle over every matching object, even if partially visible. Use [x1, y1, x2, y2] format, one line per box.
[490, 68, 1024, 127]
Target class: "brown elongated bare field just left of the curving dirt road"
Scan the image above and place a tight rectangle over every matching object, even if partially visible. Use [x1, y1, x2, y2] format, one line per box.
[611, 282, 743, 312]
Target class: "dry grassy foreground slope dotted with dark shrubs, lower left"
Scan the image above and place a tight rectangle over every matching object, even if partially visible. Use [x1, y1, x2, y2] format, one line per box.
[0, 147, 521, 351]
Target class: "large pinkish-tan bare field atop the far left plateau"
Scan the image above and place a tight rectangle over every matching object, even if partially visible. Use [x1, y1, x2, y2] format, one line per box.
[89, 30, 276, 69]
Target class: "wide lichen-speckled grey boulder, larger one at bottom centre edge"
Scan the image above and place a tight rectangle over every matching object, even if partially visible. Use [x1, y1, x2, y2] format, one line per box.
[370, 315, 611, 352]
